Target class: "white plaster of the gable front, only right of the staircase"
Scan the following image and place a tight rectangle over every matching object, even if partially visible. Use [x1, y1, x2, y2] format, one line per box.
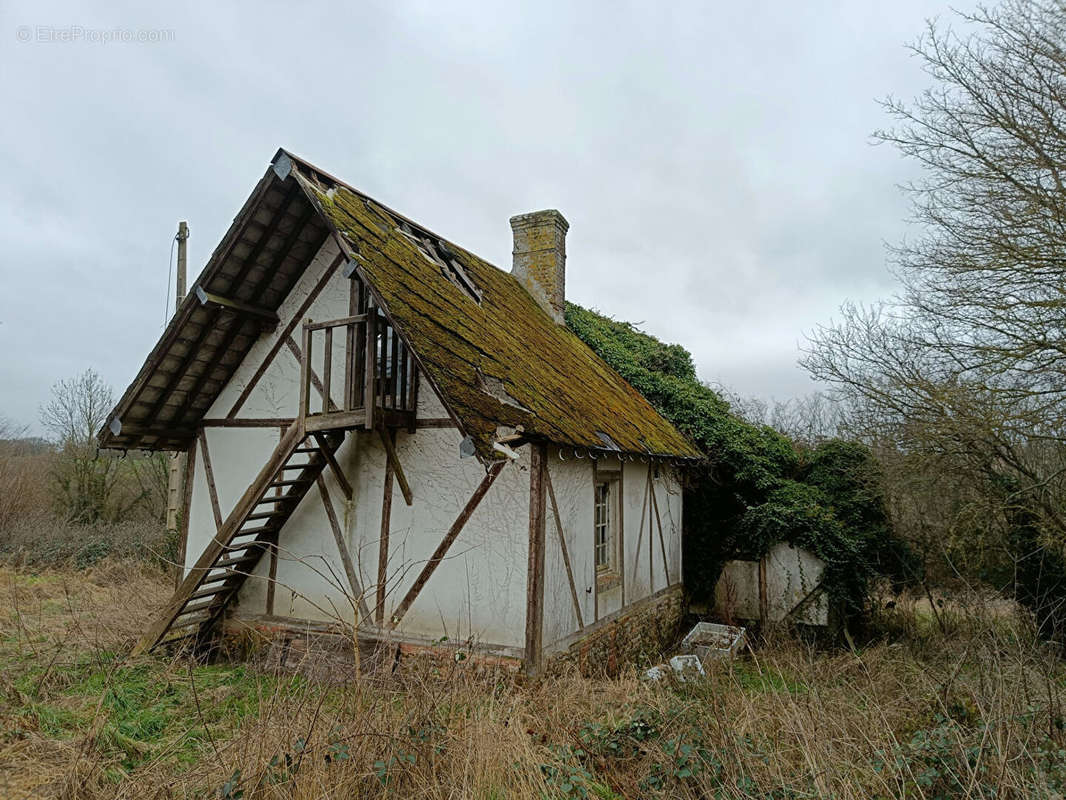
[233, 383, 529, 647]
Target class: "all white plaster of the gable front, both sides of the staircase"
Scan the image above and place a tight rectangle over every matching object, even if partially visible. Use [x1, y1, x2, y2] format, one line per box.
[187, 233, 529, 647]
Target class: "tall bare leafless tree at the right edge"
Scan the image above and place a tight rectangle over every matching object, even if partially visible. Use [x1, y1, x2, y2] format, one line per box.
[803, 0, 1066, 640]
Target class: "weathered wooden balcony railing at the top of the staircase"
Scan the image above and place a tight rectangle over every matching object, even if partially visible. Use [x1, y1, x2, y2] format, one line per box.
[300, 307, 418, 429]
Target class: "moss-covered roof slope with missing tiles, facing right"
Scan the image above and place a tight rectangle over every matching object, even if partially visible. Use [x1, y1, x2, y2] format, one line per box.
[286, 154, 699, 458]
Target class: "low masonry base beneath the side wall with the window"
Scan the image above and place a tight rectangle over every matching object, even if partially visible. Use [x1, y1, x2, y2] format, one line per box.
[545, 583, 684, 676]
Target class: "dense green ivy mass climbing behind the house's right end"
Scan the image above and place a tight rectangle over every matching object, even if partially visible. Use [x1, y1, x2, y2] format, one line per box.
[566, 304, 902, 618]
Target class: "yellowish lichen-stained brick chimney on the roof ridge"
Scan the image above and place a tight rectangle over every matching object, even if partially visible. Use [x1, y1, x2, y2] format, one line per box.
[511, 213, 570, 325]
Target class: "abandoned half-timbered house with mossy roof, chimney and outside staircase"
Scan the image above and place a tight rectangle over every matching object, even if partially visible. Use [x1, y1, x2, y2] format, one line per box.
[99, 150, 698, 672]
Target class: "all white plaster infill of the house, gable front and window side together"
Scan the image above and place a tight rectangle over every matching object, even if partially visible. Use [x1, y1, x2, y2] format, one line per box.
[180, 233, 681, 649]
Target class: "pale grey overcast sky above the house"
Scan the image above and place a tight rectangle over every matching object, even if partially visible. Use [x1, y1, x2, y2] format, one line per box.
[0, 0, 966, 439]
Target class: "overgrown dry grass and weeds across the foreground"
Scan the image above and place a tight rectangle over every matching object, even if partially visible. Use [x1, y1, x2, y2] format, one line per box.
[0, 562, 1066, 800]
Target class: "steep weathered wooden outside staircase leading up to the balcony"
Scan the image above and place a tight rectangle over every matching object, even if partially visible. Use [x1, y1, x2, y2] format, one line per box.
[132, 420, 344, 655]
